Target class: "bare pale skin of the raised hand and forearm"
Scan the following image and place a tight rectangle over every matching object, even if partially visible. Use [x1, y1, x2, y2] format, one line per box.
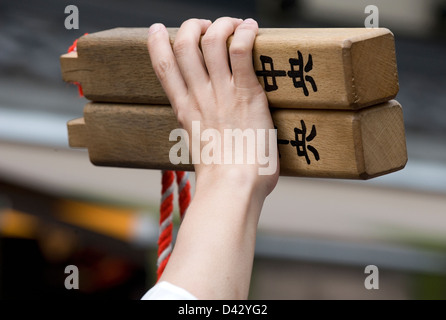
[147, 17, 279, 299]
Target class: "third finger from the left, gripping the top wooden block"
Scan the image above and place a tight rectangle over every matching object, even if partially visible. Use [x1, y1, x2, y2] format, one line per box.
[201, 17, 242, 90]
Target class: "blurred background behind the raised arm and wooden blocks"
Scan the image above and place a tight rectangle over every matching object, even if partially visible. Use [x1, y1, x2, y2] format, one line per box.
[0, 0, 446, 299]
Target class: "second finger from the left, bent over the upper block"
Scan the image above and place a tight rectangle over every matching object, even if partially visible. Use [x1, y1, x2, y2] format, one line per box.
[173, 19, 212, 92]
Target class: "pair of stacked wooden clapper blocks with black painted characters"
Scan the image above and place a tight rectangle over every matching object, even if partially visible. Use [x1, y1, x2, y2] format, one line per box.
[61, 28, 407, 179]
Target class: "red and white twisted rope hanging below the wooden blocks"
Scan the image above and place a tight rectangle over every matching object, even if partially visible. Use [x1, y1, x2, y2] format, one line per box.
[157, 170, 191, 280]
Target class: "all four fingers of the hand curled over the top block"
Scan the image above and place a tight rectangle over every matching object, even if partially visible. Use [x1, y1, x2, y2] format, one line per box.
[147, 17, 259, 111]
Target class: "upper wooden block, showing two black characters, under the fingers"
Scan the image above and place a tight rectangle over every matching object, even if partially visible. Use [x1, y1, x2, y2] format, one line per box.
[60, 28, 399, 109]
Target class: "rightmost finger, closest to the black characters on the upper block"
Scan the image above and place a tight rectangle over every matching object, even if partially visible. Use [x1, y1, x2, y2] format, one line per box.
[229, 19, 259, 88]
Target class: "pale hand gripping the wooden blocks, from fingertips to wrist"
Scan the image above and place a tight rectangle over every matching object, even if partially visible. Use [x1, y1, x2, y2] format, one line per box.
[148, 17, 279, 197]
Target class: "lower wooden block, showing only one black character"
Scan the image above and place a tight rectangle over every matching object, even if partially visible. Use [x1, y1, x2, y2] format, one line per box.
[68, 100, 407, 179]
